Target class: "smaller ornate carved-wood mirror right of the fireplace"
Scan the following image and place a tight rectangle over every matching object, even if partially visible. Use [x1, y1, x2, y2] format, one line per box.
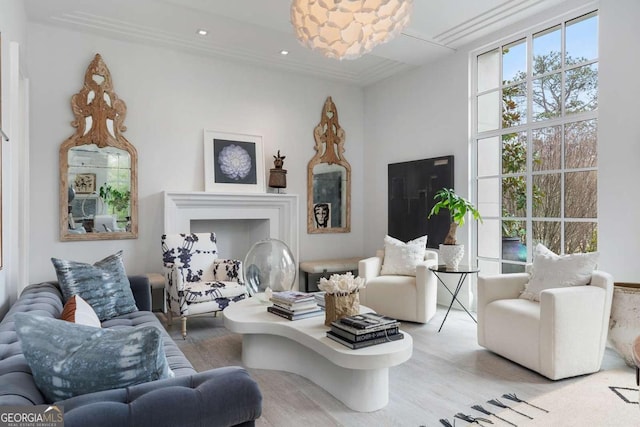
[307, 97, 351, 233]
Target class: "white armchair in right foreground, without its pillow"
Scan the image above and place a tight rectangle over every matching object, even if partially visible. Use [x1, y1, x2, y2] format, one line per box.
[478, 270, 613, 380]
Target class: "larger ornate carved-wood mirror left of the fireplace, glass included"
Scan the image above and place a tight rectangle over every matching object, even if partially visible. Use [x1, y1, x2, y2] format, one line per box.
[59, 54, 138, 241]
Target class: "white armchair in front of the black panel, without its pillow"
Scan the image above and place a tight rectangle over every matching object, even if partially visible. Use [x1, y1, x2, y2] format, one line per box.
[358, 250, 438, 323]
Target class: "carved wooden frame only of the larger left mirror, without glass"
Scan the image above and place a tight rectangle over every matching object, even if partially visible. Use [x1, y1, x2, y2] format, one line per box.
[59, 54, 138, 241]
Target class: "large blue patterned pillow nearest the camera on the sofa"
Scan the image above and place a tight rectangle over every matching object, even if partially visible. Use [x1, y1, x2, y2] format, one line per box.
[15, 313, 171, 403]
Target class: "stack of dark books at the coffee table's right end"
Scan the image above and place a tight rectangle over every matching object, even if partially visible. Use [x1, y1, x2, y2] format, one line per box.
[327, 313, 404, 349]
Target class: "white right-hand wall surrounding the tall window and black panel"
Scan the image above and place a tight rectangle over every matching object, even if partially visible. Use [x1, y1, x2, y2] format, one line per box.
[364, 0, 640, 288]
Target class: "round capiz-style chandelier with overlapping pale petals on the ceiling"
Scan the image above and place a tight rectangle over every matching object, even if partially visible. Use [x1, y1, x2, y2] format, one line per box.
[291, 0, 413, 59]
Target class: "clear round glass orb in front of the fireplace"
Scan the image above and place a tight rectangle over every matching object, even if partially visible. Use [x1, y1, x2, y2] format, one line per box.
[242, 239, 296, 296]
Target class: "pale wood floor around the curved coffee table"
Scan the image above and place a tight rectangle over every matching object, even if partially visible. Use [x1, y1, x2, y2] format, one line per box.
[159, 307, 635, 427]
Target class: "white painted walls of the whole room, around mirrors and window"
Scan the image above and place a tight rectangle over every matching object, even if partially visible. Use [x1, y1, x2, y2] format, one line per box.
[0, 0, 640, 426]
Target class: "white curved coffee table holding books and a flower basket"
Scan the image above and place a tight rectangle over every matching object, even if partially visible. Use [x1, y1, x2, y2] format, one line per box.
[223, 298, 413, 412]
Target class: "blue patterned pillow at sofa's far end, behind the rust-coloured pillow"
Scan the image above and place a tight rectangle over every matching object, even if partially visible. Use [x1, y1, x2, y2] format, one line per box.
[51, 251, 138, 322]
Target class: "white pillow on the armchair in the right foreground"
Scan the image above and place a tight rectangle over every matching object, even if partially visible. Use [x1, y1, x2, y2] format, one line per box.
[520, 243, 600, 301]
